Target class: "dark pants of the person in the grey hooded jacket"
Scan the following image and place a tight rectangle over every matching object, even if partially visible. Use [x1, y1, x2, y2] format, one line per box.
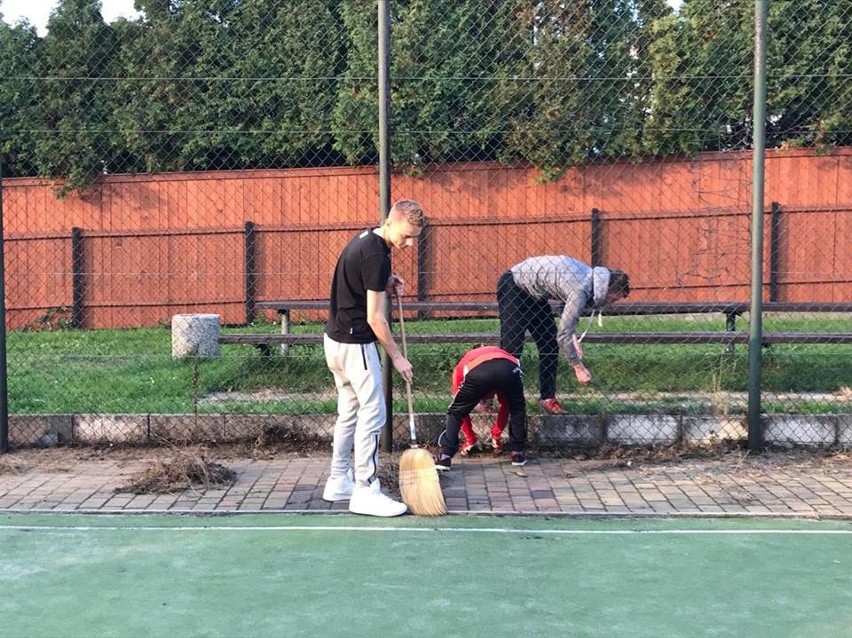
[497, 271, 559, 399]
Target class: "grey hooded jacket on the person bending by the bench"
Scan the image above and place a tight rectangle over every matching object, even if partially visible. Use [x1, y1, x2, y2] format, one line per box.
[510, 255, 610, 364]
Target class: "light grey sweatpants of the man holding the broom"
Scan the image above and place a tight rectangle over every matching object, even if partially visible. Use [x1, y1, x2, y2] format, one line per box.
[323, 335, 386, 484]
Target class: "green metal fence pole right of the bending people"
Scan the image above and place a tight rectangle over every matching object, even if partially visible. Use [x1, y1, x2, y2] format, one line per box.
[748, 0, 768, 452]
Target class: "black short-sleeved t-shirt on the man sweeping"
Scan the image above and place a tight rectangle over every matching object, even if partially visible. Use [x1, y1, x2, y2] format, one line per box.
[325, 229, 391, 343]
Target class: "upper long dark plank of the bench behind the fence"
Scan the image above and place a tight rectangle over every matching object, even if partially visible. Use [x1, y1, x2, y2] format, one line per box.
[255, 299, 852, 316]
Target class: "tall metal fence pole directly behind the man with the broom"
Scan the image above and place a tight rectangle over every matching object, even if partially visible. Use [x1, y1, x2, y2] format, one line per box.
[378, 0, 393, 452]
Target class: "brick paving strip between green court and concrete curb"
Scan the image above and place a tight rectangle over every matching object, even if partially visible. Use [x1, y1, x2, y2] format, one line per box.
[0, 455, 852, 518]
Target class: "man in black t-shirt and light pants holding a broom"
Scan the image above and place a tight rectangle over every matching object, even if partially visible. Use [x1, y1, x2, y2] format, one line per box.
[323, 200, 425, 516]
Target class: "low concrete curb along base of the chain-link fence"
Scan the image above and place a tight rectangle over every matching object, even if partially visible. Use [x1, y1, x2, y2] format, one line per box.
[9, 413, 852, 448]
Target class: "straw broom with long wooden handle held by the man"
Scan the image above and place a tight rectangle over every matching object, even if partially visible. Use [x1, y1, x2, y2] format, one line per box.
[397, 295, 447, 516]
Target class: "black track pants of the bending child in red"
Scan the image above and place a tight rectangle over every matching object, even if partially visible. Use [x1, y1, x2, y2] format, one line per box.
[438, 359, 527, 456]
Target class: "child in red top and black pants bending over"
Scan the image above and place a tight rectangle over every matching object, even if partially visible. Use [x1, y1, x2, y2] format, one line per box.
[435, 346, 527, 471]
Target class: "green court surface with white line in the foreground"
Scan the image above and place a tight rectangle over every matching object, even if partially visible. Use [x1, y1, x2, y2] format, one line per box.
[0, 514, 852, 638]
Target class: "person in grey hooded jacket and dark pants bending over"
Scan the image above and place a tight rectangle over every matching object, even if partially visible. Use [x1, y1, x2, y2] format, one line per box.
[497, 255, 630, 414]
